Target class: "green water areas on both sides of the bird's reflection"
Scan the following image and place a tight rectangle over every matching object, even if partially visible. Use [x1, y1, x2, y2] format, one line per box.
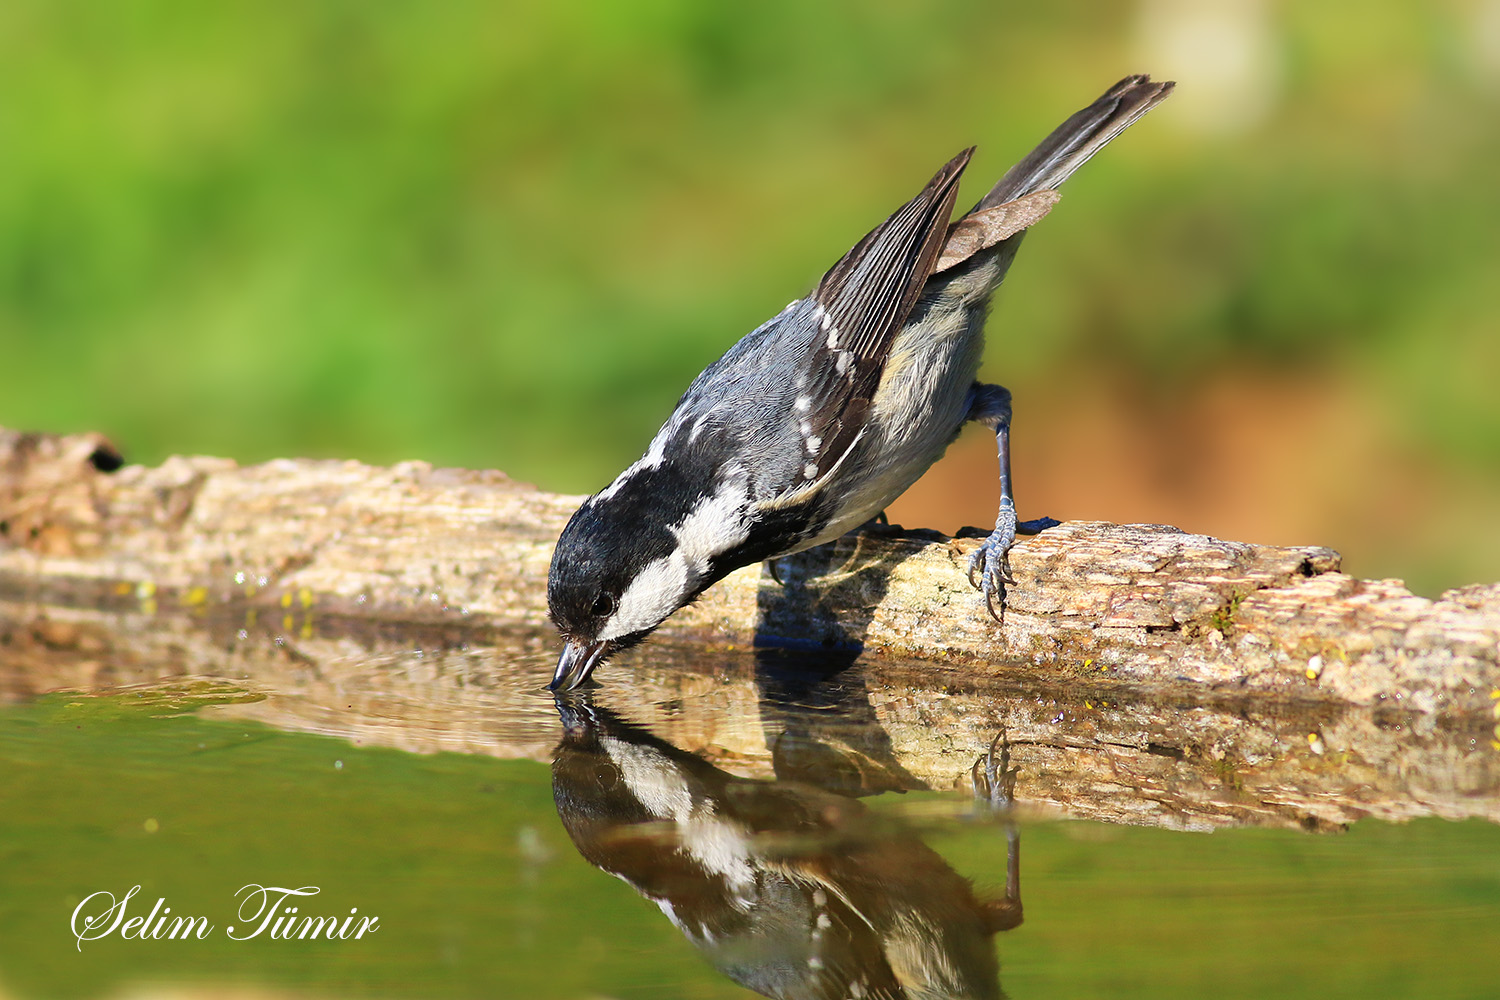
[0, 685, 1500, 999]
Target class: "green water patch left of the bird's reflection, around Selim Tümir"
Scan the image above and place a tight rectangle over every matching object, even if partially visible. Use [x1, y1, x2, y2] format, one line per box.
[0, 694, 732, 997]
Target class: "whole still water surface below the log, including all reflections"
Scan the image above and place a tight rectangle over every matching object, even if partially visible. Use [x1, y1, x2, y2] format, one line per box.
[0, 612, 1500, 999]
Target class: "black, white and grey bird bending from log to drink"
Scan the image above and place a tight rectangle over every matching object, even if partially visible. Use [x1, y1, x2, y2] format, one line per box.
[548, 75, 1175, 691]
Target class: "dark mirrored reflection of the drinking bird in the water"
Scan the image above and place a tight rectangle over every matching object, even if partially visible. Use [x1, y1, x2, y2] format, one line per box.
[552, 691, 1022, 999]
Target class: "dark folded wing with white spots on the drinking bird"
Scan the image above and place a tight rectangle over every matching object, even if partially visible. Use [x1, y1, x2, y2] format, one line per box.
[794, 147, 974, 483]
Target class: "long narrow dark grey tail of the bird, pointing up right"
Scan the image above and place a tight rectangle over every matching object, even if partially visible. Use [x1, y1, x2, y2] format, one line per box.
[974, 75, 1175, 211]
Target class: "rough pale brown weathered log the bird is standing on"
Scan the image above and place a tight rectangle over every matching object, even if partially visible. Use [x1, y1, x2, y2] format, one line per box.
[0, 430, 1500, 715]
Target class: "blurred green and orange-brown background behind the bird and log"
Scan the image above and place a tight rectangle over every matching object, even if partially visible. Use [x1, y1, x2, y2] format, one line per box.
[0, 0, 1500, 594]
